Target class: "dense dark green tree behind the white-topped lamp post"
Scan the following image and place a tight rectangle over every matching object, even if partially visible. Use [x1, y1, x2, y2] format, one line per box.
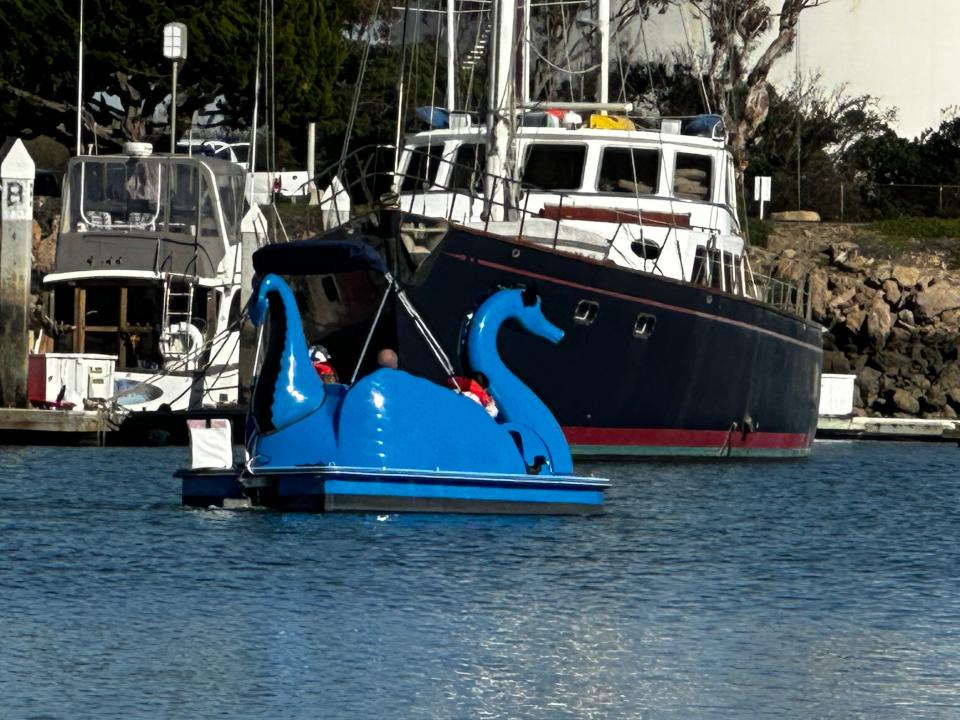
[0, 0, 343, 157]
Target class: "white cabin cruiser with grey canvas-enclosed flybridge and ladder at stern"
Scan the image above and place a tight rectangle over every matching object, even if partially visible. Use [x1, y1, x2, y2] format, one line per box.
[43, 143, 267, 424]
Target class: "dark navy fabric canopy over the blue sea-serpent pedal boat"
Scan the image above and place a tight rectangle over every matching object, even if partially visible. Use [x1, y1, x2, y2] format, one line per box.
[253, 237, 387, 276]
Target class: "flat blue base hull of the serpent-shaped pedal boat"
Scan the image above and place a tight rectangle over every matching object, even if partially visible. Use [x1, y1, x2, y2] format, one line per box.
[177, 467, 609, 515]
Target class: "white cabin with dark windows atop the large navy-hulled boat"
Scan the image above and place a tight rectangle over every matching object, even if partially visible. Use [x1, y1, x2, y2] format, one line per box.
[394, 113, 752, 294]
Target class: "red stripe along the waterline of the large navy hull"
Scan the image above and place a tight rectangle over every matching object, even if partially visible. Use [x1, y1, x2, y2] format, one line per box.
[563, 427, 811, 450]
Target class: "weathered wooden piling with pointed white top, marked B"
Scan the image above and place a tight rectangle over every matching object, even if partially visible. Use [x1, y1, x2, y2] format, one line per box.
[0, 139, 35, 408]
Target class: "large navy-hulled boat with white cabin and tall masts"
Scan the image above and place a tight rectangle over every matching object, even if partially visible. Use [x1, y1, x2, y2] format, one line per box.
[304, 0, 822, 456]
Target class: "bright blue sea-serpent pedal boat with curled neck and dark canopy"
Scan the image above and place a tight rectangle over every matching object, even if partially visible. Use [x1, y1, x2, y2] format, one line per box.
[178, 236, 609, 514]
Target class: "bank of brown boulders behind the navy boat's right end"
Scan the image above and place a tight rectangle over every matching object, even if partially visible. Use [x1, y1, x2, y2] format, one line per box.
[753, 223, 960, 419]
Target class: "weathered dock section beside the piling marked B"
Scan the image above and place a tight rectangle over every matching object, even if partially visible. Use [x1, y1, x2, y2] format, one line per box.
[0, 408, 115, 445]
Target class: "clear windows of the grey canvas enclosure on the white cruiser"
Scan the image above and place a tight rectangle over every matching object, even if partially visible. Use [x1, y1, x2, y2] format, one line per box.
[63, 156, 243, 242]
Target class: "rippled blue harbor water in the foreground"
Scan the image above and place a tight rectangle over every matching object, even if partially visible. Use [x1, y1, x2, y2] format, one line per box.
[0, 443, 960, 720]
